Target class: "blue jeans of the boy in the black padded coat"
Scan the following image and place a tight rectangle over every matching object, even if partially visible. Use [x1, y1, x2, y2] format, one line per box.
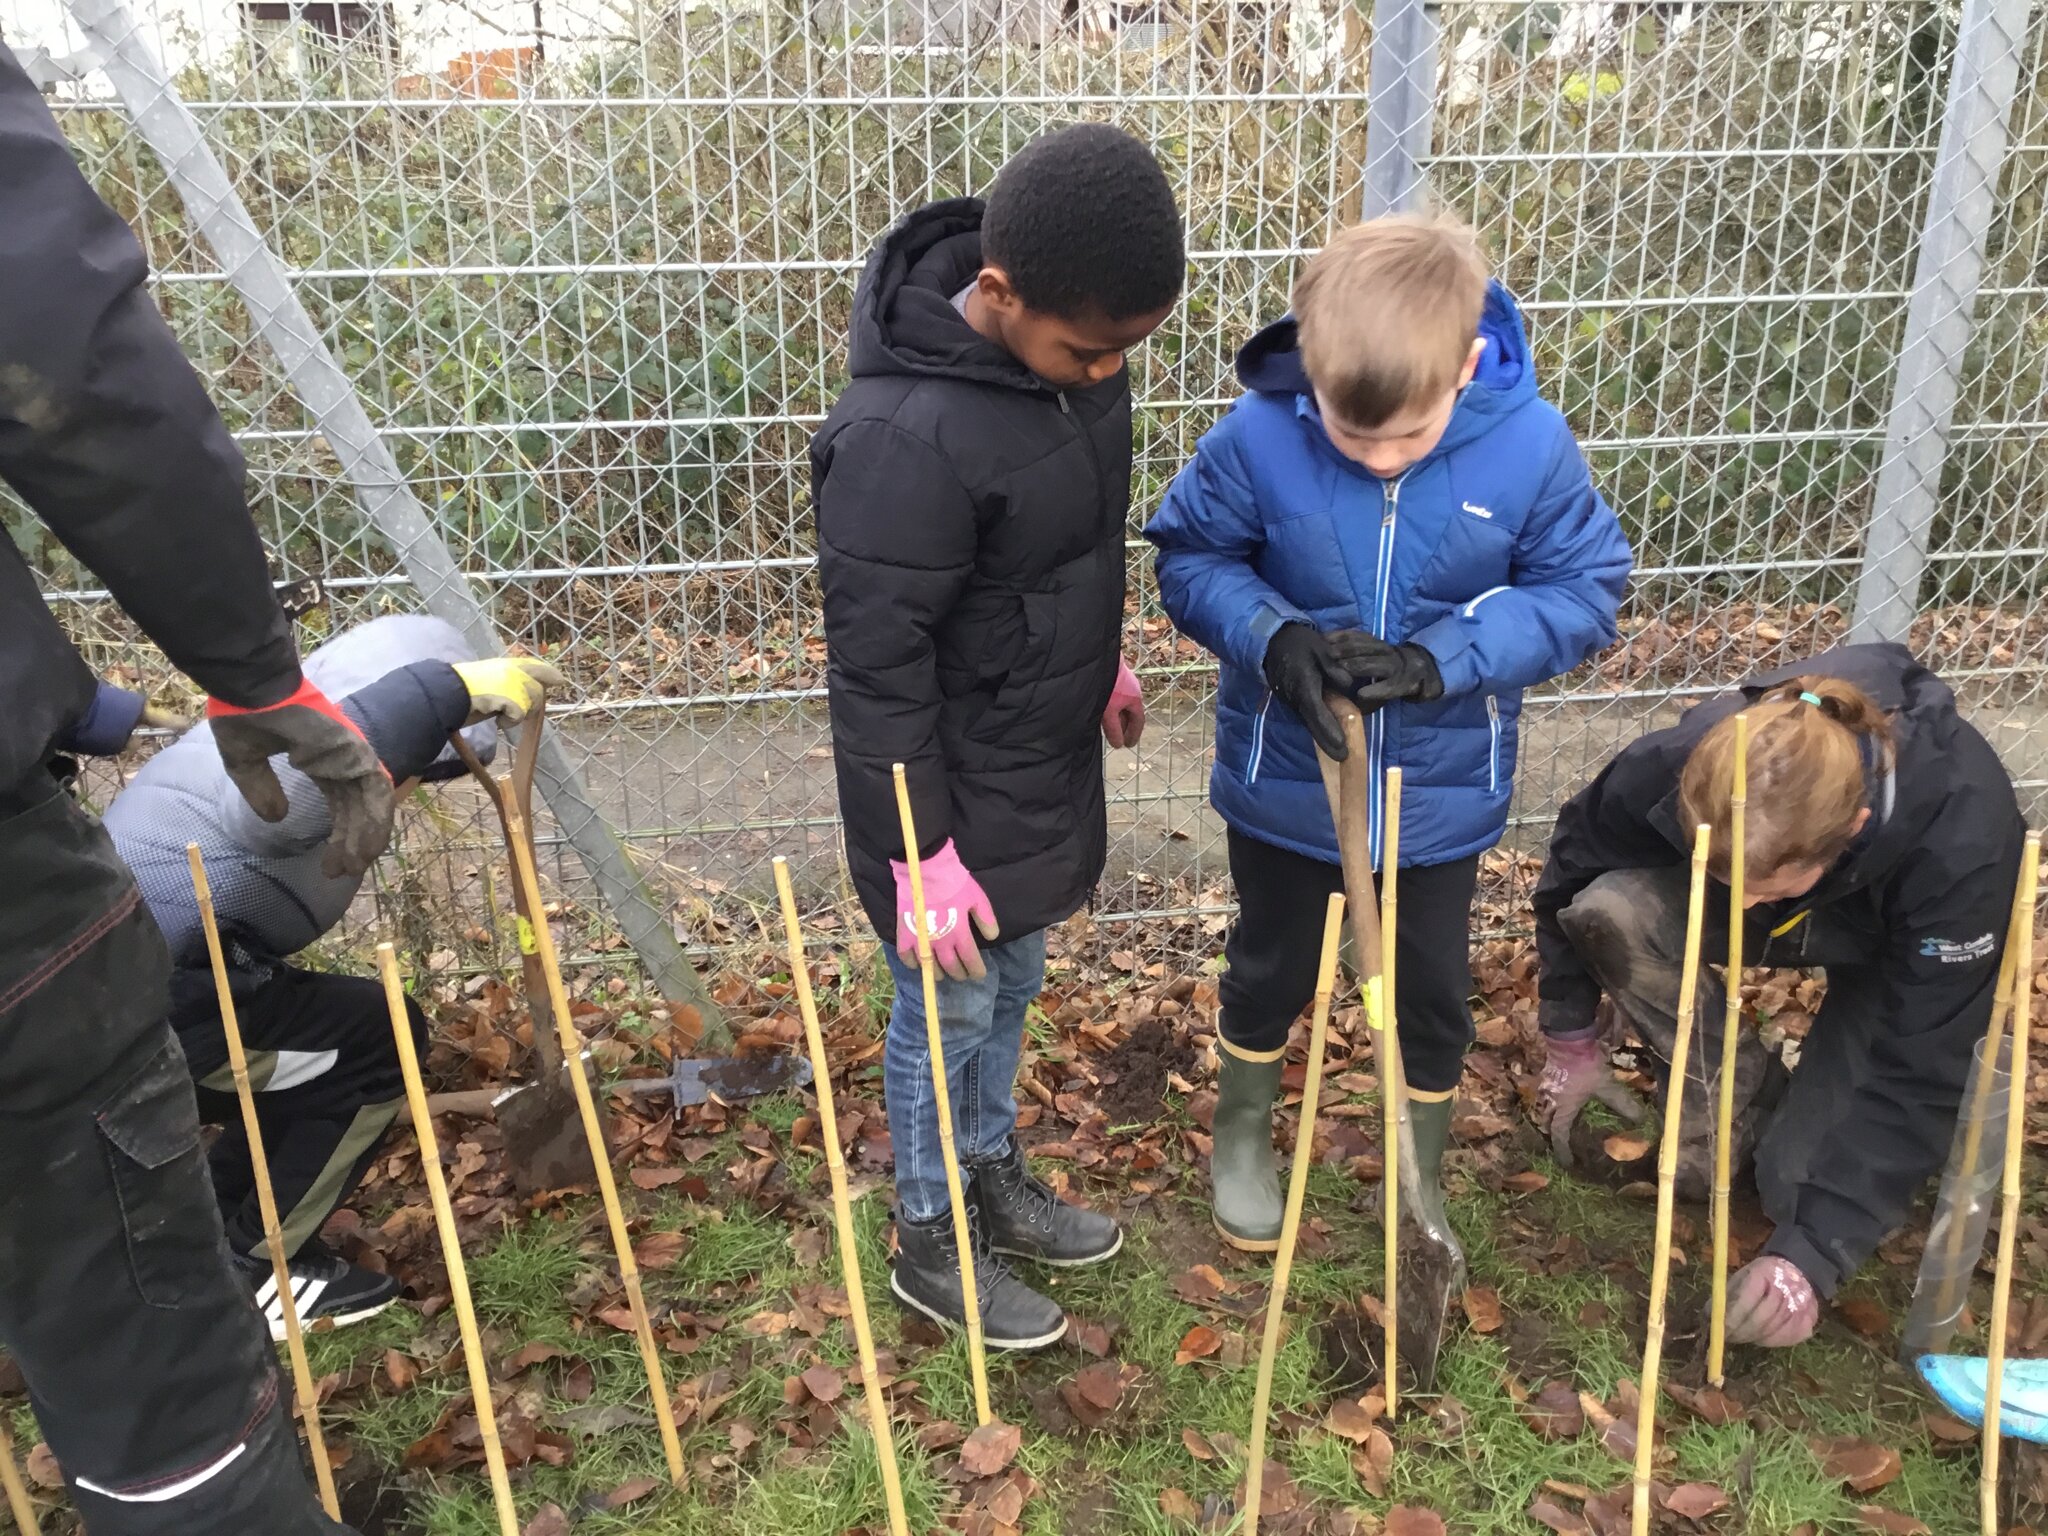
[883, 930, 1044, 1221]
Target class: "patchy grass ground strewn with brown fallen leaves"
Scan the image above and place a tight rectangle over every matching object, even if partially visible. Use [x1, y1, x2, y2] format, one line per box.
[14, 925, 2048, 1536]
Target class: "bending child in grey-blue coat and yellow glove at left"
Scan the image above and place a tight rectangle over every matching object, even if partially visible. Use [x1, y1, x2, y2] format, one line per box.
[96, 614, 561, 1339]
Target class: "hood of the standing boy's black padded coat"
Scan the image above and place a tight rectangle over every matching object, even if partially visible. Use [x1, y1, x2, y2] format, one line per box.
[848, 197, 1047, 393]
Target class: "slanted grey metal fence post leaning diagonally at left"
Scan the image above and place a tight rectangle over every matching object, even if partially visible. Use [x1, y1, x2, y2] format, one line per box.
[70, 0, 729, 1044]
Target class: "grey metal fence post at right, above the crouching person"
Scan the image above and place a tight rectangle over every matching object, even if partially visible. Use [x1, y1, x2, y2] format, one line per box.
[1849, 0, 2032, 643]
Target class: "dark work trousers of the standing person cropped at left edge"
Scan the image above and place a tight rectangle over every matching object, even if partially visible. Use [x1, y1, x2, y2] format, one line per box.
[0, 795, 338, 1536]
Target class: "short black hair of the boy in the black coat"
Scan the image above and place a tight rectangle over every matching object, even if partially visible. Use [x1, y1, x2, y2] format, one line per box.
[981, 123, 1188, 319]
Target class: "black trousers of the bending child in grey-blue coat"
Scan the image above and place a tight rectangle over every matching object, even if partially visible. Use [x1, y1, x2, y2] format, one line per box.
[170, 965, 426, 1255]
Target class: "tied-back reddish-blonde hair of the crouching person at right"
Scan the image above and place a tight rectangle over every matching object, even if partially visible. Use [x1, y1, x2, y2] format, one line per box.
[1679, 676, 1892, 881]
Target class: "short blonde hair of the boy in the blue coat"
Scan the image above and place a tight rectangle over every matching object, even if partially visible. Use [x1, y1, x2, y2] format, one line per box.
[1294, 213, 1487, 430]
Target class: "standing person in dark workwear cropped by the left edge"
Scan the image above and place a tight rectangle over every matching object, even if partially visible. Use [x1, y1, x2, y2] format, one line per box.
[0, 47, 391, 1536]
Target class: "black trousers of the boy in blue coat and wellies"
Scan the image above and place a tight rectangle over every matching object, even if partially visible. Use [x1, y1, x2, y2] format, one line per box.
[1221, 827, 1479, 1096]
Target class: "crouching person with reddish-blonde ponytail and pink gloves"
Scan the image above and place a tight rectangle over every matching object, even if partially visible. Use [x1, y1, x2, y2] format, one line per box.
[1536, 645, 2023, 1346]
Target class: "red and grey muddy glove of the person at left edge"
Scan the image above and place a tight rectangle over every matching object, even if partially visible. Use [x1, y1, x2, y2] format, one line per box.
[207, 680, 395, 881]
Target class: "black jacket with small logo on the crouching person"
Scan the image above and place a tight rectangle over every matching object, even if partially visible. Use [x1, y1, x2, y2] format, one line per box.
[1536, 645, 2023, 1288]
